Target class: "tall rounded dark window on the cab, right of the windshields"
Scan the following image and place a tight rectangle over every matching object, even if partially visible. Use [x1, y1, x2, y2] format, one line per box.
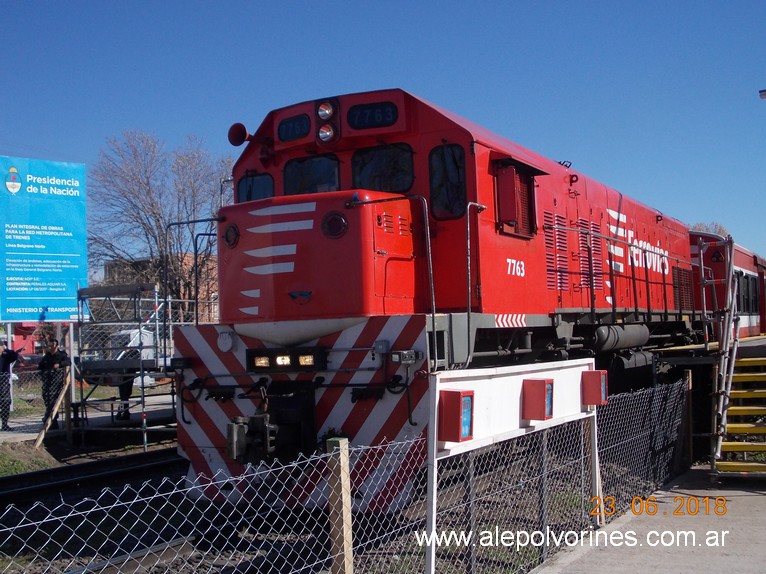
[428, 143, 466, 219]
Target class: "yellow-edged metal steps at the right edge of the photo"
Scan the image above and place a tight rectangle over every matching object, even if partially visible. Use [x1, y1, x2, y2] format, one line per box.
[713, 357, 766, 476]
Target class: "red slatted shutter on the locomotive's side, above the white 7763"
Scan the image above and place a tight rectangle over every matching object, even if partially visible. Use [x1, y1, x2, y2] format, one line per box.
[494, 160, 537, 237]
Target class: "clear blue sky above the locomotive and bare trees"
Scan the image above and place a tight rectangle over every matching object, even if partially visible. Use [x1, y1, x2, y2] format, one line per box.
[0, 0, 766, 256]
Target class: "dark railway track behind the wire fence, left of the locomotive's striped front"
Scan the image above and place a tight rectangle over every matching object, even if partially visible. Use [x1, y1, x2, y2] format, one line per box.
[0, 448, 189, 507]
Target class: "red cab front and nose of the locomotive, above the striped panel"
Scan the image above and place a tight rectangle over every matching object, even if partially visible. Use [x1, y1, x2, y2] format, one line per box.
[218, 90, 484, 344]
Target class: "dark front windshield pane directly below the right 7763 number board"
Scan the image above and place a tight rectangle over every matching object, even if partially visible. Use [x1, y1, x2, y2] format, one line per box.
[351, 143, 414, 193]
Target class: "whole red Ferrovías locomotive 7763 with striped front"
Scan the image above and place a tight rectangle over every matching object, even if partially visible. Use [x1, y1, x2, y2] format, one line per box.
[176, 89, 763, 508]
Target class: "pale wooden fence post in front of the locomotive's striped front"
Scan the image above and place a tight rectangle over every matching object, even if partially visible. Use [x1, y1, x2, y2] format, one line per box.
[327, 437, 354, 574]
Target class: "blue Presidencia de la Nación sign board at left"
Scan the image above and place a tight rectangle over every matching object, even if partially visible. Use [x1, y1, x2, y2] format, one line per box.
[0, 156, 88, 322]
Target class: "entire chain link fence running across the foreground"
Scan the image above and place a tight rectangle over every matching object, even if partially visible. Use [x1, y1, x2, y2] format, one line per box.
[0, 381, 687, 574]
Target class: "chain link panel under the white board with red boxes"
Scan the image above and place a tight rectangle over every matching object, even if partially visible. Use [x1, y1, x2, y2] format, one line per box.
[435, 418, 593, 573]
